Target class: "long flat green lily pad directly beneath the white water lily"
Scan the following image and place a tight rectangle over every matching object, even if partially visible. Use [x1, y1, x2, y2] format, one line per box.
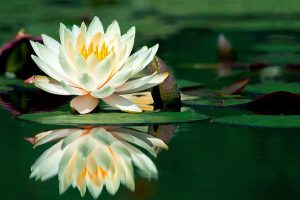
[18, 111, 209, 125]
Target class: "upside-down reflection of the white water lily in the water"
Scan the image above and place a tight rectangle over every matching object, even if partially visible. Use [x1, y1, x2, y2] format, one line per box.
[31, 127, 167, 198]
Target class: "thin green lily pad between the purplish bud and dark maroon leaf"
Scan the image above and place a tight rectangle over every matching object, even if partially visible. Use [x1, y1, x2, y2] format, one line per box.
[184, 99, 252, 107]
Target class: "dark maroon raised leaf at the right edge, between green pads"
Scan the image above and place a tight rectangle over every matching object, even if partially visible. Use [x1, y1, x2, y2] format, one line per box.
[248, 91, 300, 115]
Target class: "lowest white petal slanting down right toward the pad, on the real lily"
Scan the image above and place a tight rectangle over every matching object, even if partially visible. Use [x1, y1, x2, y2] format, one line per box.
[103, 94, 142, 112]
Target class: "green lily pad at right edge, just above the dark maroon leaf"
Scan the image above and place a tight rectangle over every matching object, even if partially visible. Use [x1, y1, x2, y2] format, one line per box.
[246, 81, 300, 94]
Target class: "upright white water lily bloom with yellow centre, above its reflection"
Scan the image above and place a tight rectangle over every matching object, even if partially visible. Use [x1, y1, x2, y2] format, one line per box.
[26, 17, 168, 114]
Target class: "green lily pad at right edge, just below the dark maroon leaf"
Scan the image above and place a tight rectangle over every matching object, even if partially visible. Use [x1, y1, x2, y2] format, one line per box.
[213, 114, 300, 128]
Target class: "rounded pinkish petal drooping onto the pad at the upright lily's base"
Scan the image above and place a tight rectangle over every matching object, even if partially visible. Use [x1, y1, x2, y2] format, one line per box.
[70, 95, 99, 114]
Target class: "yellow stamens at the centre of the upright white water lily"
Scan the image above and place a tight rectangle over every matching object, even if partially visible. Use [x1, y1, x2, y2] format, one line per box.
[80, 42, 114, 62]
